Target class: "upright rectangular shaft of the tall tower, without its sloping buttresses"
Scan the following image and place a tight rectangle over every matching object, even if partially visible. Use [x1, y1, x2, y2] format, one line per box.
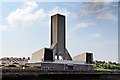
[51, 14, 65, 55]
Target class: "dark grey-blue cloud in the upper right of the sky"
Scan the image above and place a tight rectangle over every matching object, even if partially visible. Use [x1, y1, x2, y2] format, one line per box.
[78, 0, 118, 20]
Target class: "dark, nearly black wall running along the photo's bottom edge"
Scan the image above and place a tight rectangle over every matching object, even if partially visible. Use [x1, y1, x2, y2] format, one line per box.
[2, 69, 120, 80]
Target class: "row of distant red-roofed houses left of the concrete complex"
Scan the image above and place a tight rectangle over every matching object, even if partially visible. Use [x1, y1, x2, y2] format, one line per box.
[0, 57, 30, 65]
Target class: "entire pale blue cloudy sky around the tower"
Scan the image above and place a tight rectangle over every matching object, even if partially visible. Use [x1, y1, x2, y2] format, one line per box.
[0, 0, 118, 62]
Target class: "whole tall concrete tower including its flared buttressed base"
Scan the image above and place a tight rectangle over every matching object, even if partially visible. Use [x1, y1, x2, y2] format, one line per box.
[50, 14, 72, 60]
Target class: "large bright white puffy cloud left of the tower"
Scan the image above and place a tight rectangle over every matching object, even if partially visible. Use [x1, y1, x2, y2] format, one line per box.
[7, 1, 46, 26]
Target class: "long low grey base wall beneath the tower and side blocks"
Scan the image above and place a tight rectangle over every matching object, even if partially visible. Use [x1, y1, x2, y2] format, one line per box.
[27, 62, 93, 71]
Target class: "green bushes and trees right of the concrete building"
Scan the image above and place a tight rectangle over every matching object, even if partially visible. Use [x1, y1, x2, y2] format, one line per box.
[93, 61, 120, 70]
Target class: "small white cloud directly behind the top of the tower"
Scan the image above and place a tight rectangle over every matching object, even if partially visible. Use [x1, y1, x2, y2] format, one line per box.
[48, 7, 70, 16]
